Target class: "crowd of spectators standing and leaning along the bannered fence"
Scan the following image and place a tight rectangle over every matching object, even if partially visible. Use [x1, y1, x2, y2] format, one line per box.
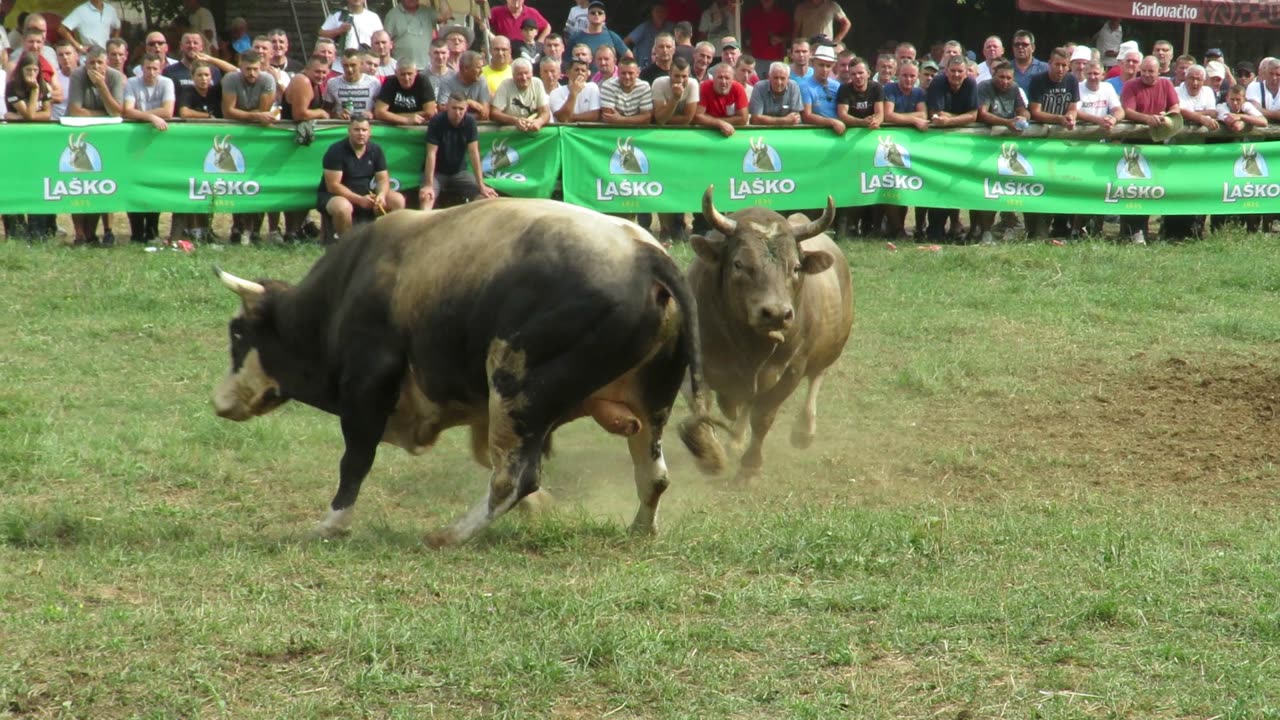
[0, 0, 1280, 245]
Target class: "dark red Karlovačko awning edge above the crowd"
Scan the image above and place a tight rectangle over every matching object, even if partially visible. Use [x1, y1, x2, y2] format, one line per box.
[1018, 0, 1280, 27]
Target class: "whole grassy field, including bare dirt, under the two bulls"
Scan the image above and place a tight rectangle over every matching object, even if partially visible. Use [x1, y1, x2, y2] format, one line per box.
[0, 230, 1280, 720]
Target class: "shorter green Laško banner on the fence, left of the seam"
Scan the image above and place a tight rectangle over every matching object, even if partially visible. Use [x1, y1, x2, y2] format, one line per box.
[0, 123, 561, 214]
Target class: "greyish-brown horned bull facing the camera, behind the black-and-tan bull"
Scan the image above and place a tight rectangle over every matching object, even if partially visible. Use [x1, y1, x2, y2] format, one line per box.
[687, 188, 854, 480]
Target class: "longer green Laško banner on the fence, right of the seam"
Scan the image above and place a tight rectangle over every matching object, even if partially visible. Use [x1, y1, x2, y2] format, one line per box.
[562, 128, 1280, 215]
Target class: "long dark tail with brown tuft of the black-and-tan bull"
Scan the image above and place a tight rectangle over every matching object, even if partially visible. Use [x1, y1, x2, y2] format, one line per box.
[653, 252, 728, 475]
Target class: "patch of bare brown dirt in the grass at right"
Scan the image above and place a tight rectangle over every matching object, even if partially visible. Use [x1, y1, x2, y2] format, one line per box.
[997, 356, 1280, 500]
